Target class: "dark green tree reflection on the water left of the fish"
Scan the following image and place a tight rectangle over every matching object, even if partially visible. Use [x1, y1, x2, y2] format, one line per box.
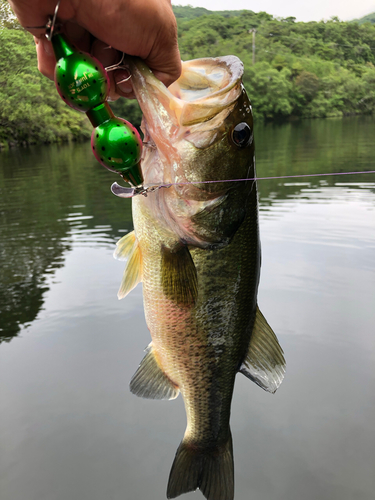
[0, 144, 131, 340]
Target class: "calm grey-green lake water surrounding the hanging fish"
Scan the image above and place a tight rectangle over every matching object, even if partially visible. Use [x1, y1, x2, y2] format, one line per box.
[0, 117, 375, 500]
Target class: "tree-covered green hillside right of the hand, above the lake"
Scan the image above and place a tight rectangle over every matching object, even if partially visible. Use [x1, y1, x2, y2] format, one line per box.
[174, 7, 375, 120]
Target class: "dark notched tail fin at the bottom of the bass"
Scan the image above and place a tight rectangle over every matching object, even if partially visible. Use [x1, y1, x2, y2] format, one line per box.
[167, 431, 234, 500]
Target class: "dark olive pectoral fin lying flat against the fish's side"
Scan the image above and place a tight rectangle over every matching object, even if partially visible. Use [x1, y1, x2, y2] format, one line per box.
[161, 246, 198, 307]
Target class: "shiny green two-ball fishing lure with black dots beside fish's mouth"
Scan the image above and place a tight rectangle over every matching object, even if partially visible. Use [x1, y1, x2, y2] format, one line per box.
[39, 2, 148, 193]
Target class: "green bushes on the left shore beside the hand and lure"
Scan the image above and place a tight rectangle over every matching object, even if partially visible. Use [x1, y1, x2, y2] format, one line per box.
[0, 15, 91, 146]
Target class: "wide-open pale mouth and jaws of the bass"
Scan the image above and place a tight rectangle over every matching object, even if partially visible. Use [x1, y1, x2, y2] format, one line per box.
[126, 56, 243, 141]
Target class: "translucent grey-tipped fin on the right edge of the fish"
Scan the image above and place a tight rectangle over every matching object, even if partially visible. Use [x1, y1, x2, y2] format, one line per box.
[240, 307, 285, 393]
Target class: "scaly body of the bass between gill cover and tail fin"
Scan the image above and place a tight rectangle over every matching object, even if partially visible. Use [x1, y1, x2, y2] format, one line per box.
[133, 190, 260, 448]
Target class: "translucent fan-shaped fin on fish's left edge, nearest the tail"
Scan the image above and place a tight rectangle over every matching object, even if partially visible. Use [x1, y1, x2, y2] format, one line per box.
[130, 343, 180, 399]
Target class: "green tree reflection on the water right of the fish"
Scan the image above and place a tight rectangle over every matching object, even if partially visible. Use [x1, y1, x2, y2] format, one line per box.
[255, 117, 375, 204]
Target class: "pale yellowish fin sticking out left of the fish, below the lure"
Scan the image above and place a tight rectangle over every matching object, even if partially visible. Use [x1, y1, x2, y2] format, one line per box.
[114, 231, 142, 299]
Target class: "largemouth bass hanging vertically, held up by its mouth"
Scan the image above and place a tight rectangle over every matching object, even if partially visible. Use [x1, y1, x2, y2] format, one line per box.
[115, 56, 285, 500]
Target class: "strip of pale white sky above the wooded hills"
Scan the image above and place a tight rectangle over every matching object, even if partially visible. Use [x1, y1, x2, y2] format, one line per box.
[172, 0, 375, 22]
